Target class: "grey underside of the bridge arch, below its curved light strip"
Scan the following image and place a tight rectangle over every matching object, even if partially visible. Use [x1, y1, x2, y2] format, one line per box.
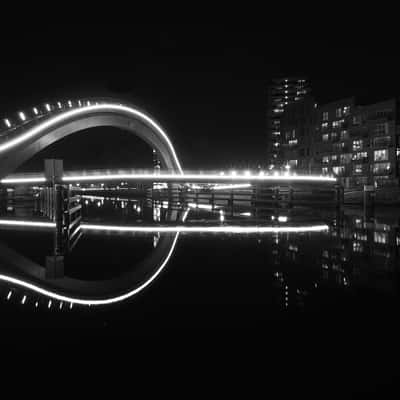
[0, 111, 181, 178]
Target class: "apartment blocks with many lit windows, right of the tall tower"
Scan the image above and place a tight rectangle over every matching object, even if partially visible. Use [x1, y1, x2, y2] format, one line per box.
[281, 98, 400, 188]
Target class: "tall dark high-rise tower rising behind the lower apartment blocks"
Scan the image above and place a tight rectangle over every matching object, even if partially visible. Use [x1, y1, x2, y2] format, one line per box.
[267, 77, 310, 168]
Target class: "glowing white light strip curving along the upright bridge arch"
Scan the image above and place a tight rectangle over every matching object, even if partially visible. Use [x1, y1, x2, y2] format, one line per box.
[0, 103, 183, 173]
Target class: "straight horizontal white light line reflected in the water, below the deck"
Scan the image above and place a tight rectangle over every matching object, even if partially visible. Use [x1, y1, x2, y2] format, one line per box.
[0, 220, 329, 233]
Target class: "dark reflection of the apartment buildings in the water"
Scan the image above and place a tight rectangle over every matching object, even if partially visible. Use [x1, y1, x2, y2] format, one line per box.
[272, 210, 400, 309]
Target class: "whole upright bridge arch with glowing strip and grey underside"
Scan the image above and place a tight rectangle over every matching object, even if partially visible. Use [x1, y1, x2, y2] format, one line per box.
[0, 101, 183, 178]
